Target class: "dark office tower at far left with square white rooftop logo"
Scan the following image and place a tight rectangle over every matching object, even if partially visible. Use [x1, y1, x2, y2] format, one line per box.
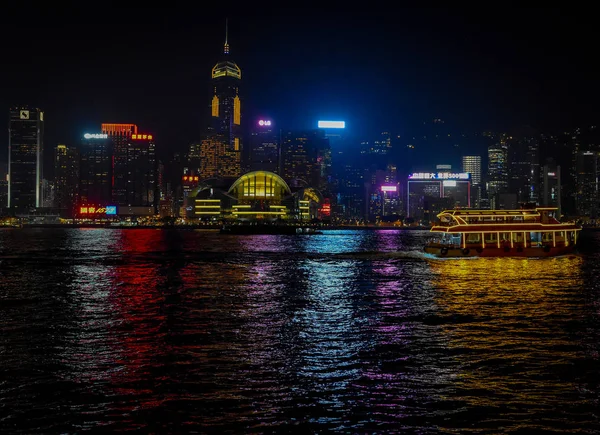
[8, 106, 44, 213]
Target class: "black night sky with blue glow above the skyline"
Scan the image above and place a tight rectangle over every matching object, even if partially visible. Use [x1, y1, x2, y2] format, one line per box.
[0, 6, 600, 161]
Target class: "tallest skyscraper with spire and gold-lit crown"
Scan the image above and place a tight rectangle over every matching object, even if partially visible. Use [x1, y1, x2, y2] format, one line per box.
[201, 20, 242, 177]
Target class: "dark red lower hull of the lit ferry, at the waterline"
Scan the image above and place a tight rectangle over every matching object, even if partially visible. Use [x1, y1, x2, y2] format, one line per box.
[424, 244, 575, 258]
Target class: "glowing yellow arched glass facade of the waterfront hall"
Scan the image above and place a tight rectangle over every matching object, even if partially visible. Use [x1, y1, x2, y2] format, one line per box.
[227, 171, 292, 201]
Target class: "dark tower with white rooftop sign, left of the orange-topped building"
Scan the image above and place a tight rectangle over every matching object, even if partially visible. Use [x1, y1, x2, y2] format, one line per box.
[79, 133, 114, 207]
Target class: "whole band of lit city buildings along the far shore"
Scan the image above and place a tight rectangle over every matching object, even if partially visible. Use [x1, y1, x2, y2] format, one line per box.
[0, 23, 600, 227]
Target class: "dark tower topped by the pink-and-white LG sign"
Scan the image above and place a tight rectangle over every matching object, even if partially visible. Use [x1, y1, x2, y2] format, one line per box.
[244, 119, 280, 174]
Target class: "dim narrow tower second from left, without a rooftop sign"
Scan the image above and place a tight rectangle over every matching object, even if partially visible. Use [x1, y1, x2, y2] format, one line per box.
[54, 144, 80, 217]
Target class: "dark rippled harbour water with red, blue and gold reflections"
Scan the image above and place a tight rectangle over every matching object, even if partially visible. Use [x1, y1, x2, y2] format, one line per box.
[0, 229, 600, 434]
